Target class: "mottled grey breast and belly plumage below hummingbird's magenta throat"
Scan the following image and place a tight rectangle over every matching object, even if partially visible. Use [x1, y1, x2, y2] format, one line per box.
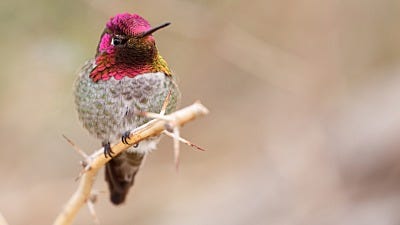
[75, 61, 179, 141]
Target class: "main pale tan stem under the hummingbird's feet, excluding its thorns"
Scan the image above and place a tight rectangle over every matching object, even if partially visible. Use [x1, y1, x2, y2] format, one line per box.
[54, 102, 208, 225]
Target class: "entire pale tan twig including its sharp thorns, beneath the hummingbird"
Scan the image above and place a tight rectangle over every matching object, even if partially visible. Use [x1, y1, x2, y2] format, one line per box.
[54, 102, 208, 225]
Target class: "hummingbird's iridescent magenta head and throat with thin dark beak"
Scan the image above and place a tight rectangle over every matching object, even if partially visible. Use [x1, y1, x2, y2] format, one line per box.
[90, 13, 170, 82]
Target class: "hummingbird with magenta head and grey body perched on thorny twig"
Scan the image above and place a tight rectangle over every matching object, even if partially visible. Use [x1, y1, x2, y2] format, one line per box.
[74, 13, 180, 205]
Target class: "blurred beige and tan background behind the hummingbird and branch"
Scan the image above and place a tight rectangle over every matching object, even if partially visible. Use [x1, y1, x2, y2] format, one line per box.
[0, 0, 400, 225]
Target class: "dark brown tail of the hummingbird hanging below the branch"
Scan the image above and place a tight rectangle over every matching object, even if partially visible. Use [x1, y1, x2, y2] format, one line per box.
[105, 152, 144, 205]
